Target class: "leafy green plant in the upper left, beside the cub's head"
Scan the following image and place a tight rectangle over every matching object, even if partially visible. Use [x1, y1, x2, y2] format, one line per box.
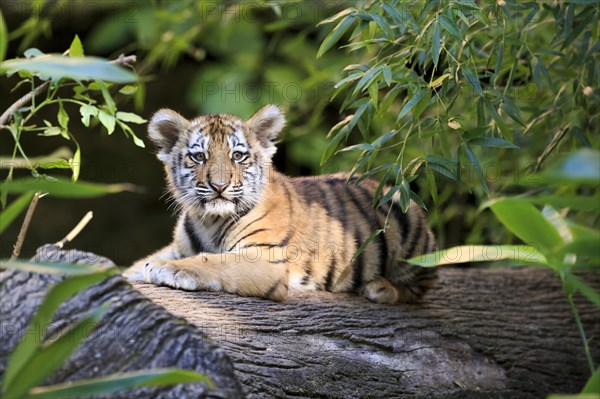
[0, 36, 145, 231]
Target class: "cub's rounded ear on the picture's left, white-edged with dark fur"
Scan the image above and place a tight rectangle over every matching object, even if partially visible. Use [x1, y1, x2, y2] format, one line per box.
[148, 108, 190, 161]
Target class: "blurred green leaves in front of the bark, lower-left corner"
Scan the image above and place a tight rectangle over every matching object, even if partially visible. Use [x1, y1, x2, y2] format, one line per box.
[2, 261, 213, 398]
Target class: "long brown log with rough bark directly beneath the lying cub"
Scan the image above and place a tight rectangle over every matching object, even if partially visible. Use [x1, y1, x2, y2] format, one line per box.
[135, 268, 600, 398]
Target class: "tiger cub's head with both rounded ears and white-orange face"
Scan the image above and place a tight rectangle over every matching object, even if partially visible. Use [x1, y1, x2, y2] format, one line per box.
[148, 105, 285, 217]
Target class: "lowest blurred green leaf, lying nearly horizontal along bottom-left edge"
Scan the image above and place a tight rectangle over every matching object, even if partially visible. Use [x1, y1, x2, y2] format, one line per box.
[29, 369, 214, 399]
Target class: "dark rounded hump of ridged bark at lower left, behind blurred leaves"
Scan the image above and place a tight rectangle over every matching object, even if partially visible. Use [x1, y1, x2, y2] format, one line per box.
[0, 246, 243, 399]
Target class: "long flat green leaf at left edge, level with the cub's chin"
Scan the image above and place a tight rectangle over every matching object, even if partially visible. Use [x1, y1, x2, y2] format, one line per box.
[0, 177, 135, 198]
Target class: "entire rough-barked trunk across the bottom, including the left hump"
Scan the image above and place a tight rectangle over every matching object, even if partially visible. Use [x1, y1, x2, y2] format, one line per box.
[0, 248, 600, 398]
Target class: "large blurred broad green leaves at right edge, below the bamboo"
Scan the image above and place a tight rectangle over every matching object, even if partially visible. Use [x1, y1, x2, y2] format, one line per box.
[408, 149, 600, 386]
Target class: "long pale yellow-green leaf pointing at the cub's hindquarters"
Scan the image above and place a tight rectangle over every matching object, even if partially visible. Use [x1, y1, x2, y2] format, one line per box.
[406, 245, 546, 267]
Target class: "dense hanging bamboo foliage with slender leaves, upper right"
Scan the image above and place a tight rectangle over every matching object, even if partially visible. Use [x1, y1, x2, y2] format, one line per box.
[319, 0, 600, 242]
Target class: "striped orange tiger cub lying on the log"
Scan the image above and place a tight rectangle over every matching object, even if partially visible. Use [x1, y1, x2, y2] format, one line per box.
[125, 105, 436, 304]
